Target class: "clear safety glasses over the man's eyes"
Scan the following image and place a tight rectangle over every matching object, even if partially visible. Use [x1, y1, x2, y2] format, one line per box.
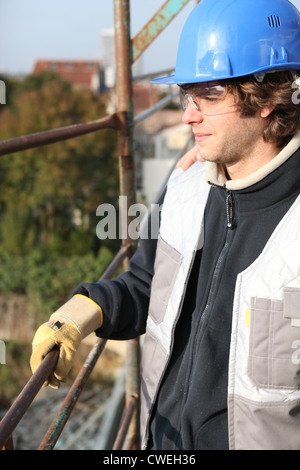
[180, 85, 237, 116]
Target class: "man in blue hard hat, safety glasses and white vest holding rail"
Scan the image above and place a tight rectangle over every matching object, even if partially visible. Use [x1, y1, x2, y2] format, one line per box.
[32, 0, 300, 450]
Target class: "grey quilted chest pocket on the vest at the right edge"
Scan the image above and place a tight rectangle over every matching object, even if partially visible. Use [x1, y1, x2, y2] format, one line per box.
[248, 287, 300, 390]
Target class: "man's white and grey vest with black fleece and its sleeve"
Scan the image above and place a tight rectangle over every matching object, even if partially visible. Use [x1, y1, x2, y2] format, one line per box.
[76, 131, 300, 449]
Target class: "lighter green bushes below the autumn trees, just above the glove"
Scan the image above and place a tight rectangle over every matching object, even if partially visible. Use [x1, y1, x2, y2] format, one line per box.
[0, 247, 113, 324]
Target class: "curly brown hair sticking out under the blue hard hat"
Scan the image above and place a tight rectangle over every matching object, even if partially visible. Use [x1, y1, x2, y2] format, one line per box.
[222, 70, 300, 148]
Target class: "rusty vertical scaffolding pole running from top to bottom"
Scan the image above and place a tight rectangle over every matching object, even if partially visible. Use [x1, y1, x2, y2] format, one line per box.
[114, 0, 140, 449]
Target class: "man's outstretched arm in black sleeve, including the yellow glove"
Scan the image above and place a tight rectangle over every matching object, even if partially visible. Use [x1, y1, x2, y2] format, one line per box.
[30, 204, 161, 388]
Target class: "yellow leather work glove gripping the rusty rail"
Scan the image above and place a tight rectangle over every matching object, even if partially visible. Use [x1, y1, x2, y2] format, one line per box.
[30, 295, 103, 388]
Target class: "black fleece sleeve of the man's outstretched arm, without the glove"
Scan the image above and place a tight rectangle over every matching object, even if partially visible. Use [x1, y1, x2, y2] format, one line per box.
[72, 193, 164, 340]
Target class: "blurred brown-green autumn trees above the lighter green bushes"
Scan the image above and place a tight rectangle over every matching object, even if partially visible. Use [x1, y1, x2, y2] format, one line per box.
[0, 72, 119, 255]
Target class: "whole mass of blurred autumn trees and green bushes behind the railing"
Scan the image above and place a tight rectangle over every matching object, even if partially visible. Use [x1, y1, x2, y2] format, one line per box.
[0, 73, 119, 322]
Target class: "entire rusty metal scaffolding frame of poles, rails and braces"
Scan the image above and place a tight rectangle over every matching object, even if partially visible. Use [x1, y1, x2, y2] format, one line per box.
[0, 0, 198, 450]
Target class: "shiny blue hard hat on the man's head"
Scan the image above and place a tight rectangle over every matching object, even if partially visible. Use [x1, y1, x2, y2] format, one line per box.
[152, 0, 300, 84]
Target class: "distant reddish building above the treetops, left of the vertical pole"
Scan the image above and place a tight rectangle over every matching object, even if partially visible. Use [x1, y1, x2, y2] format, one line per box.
[33, 60, 100, 91]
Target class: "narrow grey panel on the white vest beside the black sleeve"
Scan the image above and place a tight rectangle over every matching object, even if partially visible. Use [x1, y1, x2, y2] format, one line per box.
[149, 237, 182, 325]
